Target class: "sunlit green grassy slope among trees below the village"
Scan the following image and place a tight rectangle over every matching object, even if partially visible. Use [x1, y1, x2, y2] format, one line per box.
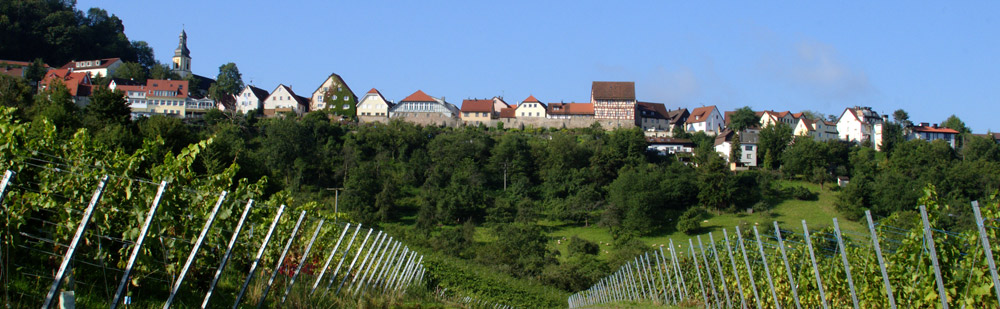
[541, 181, 866, 257]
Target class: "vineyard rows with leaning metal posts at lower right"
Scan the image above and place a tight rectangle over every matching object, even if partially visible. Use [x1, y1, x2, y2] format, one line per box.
[567, 192, 1000, 308]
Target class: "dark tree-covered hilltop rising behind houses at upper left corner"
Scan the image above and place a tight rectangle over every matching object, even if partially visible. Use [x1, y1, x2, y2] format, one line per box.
[0, 0, 155, 68]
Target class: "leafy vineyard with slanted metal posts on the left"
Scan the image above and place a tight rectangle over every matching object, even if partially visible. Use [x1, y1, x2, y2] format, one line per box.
[0, 109, 450, 308]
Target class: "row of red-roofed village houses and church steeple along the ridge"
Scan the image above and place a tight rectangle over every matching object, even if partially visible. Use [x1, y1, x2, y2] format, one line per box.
[0, 31, 1000, 169]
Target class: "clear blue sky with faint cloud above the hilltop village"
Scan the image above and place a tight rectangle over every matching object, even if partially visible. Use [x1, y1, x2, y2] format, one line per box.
[77, 0, 1000, 132]
